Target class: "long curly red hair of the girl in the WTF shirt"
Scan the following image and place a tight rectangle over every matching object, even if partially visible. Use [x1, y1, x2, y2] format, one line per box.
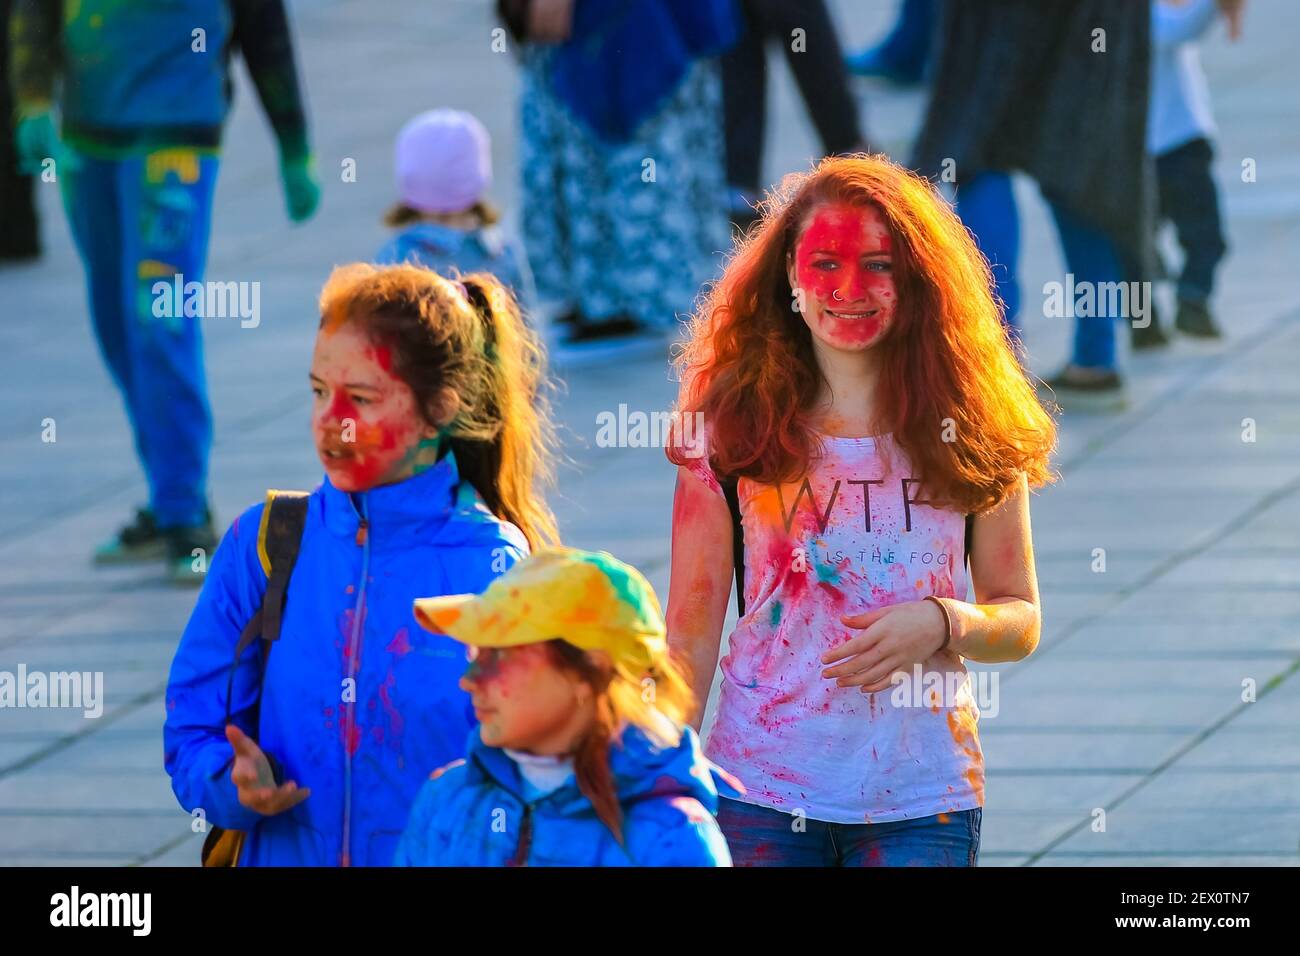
[668, 155, 1056, 512]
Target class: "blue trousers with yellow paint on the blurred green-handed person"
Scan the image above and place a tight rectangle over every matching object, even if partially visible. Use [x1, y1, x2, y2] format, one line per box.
[60, 147, 217, 528]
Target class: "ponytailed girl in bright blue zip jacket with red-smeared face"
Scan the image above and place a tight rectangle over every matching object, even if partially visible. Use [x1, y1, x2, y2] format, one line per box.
[164, 265, 556, 866]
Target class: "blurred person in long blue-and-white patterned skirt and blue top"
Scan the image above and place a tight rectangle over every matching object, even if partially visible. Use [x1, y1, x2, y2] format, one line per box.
[498, 0, 738, 362]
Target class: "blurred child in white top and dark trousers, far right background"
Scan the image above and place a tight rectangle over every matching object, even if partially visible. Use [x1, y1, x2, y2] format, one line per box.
[1134, 0, 1244, 349]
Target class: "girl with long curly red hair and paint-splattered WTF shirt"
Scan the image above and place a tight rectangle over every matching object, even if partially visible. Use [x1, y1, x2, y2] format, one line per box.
[668, 155, 1056, 866]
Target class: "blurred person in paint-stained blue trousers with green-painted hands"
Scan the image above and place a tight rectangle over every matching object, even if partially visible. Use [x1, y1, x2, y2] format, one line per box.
[9, 0, 320, 585]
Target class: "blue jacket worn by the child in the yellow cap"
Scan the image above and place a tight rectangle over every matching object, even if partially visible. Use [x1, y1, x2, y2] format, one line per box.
[395, 726, 744, 866]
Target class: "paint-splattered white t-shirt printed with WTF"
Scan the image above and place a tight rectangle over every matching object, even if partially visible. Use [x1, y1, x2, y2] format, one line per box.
[688, 436, 984, 823]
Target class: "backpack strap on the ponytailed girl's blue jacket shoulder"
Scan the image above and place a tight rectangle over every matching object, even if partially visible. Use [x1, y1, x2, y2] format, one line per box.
[226, 490, 308, 723]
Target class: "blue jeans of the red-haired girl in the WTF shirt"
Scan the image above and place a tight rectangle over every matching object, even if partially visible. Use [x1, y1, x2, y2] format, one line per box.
[718, 797, 983, 866]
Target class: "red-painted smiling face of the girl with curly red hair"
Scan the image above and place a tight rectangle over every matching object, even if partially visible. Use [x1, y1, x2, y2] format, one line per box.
[794, 203, 898, 351]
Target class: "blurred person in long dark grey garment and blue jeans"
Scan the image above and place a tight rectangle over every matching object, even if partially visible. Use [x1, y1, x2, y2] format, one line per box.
[914, 0, 1153, 411]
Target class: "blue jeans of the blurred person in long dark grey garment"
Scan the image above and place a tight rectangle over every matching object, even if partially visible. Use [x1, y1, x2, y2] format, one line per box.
[957, 172, 1128, 368]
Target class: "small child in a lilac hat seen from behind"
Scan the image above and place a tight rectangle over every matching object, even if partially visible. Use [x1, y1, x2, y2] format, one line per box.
[374, 109, 536, 316]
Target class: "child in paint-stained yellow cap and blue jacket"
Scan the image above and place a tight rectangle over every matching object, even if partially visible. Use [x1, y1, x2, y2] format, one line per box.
[397, 548, 742, 866]
